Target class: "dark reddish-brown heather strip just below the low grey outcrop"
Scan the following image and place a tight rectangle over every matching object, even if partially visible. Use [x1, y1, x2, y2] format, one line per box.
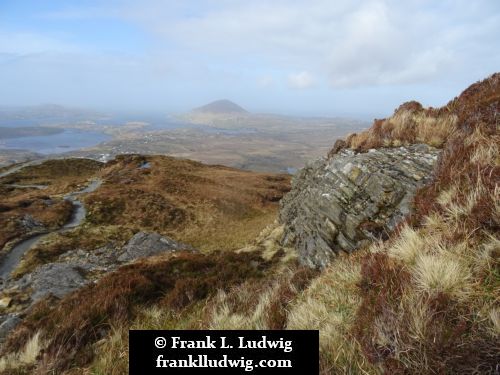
[1, 252, 272, 373]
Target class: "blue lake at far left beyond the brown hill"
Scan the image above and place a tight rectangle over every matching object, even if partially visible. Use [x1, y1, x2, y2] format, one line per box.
[0, 129, 111, 154]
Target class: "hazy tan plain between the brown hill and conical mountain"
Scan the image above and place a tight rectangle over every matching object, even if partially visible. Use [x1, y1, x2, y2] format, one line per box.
[68, 121, 365, 173]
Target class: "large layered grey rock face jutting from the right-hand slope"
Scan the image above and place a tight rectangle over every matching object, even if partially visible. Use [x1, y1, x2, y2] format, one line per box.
[280, 145, 439, 268]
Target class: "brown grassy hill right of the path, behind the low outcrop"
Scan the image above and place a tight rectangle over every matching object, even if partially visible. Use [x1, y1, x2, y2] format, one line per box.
[85, 155, 290, 251]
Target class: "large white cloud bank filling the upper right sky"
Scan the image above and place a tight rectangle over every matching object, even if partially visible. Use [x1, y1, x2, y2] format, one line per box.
[122, 0, 500, 87]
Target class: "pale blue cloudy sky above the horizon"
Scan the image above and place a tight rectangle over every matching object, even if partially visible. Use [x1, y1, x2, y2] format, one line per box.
[0, 0, 500, 118]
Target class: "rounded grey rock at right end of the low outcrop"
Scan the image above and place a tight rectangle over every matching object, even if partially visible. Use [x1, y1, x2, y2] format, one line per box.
[118, 232, 196, 262]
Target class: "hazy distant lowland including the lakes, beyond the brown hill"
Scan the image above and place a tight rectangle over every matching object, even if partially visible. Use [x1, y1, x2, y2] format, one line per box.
[0, 108, 367, 173]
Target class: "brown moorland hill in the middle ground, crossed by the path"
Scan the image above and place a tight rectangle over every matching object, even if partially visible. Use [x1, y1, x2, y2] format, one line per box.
[0, 155, 290, 277]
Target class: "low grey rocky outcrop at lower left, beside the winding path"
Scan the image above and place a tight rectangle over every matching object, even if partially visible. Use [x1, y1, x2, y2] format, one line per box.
[0, 232, 197, 344]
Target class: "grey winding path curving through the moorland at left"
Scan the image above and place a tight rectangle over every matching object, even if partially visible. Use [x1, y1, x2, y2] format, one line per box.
[0, 178, 102, 279]
